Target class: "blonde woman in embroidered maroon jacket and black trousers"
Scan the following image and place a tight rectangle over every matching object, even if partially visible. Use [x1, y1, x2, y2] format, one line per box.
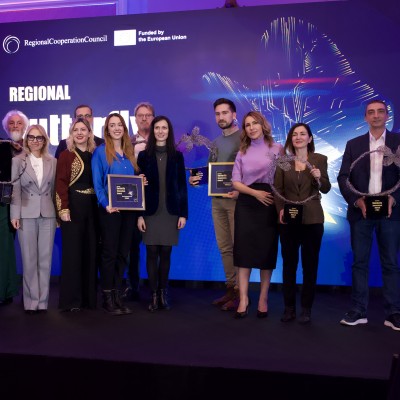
[56, 118, 97, 312]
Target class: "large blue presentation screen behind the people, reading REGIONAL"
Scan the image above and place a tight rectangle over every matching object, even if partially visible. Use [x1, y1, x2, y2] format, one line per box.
[0, 1, 400, 286]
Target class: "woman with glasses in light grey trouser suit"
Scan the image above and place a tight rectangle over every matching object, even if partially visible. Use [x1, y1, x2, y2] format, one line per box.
[10, 125, 57, 314]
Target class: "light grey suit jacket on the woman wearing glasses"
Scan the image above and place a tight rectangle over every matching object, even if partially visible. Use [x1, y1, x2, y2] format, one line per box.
[10, 154, 57, 219]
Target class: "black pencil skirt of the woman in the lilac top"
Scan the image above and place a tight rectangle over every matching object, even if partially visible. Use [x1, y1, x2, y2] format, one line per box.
[233, 183, 278, 269]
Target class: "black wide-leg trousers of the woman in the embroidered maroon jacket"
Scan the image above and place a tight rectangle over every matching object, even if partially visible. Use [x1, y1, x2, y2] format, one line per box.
[59, 191, 97, 309]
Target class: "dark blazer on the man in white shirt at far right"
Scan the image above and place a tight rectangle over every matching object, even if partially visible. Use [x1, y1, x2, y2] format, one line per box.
[337, 131, 400, 221]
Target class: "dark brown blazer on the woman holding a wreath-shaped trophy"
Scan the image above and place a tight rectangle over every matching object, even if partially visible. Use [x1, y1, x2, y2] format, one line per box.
[274, 153, 331, 224]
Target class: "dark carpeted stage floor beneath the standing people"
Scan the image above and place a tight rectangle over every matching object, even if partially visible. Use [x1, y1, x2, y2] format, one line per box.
[0, 283, 400, 380]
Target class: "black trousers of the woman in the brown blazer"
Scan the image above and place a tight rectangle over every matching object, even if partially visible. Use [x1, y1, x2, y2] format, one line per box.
[279, 224, 324, 308]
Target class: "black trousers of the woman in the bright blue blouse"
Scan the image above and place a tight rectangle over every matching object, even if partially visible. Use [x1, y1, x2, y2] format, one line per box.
[99, 207, 136, 290]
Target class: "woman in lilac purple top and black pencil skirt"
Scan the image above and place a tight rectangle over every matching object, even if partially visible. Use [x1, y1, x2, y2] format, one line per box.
[232, 111, 283, 318]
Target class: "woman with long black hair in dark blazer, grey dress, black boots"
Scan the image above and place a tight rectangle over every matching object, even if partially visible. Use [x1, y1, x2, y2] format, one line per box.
[138, 116, 188, 312]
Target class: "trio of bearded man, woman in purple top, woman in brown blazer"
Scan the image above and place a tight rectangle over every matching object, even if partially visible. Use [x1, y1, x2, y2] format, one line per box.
[189, 98, 330, 323]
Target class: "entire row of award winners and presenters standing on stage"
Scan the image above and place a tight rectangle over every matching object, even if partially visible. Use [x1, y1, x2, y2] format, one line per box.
[0, 98, 400, 330]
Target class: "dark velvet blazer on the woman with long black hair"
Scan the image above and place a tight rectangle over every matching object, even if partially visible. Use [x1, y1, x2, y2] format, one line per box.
[137, 150, 188, 219]
